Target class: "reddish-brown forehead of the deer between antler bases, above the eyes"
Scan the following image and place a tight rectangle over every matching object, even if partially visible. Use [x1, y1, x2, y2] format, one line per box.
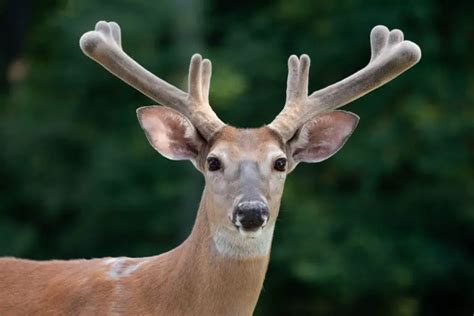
[210, 126, 282, 158]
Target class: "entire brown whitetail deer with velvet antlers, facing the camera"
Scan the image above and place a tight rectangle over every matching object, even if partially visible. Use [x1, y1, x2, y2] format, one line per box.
[0, 21, 421, 315]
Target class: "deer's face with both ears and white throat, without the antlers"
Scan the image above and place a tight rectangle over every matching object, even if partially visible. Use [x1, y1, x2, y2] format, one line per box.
[137, 106, 358, 258]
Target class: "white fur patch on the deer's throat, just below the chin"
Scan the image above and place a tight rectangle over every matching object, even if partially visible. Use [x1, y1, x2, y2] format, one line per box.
[212, 225, 275, 259]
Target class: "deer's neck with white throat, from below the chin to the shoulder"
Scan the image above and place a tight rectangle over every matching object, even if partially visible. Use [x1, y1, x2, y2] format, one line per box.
[163, 189, 273, 315]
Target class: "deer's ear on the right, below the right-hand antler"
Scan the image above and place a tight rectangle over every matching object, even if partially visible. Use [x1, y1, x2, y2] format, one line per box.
[288, 111, 359, 165]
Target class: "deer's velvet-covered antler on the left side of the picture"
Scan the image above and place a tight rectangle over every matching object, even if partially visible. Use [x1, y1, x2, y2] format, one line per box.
[80, 21, 225, 140]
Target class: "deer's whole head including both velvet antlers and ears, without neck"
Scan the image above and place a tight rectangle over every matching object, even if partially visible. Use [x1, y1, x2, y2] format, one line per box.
[80, 21, 421, 251]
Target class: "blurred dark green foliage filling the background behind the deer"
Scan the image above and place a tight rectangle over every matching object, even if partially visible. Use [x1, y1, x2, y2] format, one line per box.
[0, 0, 474, 316]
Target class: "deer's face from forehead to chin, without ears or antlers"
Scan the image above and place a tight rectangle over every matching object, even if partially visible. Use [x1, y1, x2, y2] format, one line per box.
[199, 126, 288, 238]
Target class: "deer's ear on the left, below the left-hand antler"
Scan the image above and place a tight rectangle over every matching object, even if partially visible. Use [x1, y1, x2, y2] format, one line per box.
[137, 106, 205, 160]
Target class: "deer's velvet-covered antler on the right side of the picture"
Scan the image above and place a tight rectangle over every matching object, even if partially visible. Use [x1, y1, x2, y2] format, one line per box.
[268, 25, 421, 141]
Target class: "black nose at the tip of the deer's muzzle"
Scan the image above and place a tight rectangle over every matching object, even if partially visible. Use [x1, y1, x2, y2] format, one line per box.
[233, 201, 269, 230]
